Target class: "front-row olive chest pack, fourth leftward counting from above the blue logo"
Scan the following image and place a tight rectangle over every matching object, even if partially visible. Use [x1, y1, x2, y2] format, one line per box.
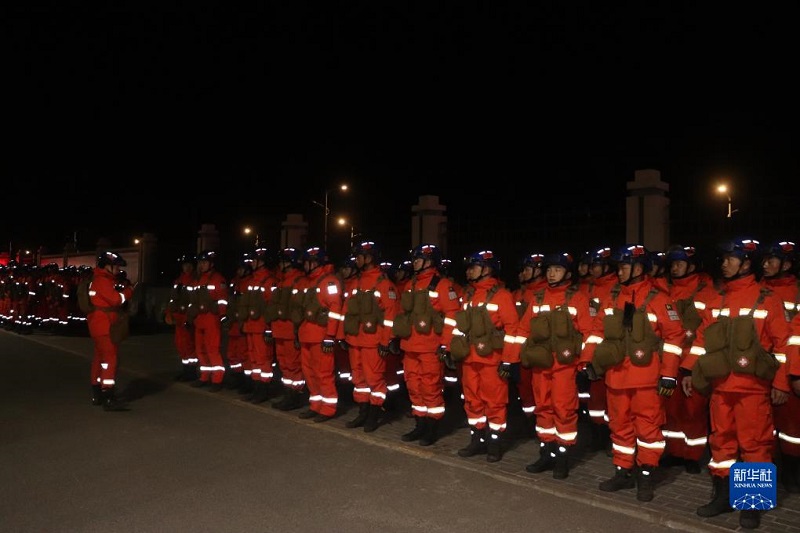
[450, 284, 505, 361]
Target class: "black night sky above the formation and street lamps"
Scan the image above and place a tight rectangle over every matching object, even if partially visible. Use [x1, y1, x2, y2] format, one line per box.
[6, 1, 800, 270]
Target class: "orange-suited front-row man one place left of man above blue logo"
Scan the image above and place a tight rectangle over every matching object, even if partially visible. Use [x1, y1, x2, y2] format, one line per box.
[587, 244, 685, 502]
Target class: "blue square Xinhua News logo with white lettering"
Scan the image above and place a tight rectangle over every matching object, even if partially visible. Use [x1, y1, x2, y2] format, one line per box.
[729, 463, 778, 511]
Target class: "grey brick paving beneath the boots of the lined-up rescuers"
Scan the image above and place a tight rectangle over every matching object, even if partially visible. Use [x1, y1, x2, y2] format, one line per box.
[7, 326, 800, 532]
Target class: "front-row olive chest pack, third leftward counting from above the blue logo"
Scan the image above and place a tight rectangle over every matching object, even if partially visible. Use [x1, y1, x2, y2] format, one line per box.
[519, 285, 583, 368]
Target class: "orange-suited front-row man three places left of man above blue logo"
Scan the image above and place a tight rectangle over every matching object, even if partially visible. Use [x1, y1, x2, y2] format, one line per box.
[450, 250, 519, 463]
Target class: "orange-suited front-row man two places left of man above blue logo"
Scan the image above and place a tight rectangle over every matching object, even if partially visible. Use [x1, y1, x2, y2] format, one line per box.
[516, 252, 599, 479]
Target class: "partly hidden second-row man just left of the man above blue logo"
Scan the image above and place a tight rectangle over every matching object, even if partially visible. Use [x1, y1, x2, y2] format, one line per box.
[661, 245, 714, 474]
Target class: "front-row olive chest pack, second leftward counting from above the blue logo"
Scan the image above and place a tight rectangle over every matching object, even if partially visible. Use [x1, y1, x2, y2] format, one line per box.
[592, 285, 663, 376]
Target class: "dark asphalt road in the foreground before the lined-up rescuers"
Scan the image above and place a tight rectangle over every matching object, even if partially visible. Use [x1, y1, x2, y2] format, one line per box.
[0, 331, 692, 533]
